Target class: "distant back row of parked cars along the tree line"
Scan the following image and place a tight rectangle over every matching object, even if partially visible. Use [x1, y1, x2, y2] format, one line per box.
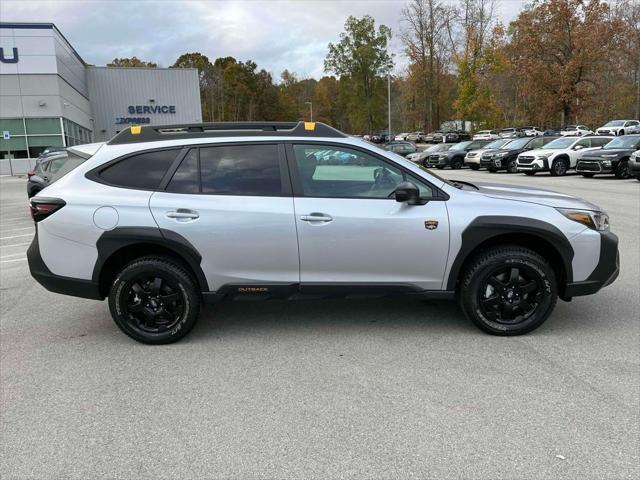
[392, 120, 640, 143]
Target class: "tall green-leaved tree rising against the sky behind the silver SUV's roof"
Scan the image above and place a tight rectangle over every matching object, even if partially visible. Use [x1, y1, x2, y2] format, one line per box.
[324, 15, 393, 133]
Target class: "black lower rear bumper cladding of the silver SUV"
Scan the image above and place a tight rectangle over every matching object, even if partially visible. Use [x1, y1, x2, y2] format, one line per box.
[27, 229, 104, 300]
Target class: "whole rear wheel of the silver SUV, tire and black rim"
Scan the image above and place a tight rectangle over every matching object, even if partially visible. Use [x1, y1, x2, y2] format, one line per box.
[109, 256, 200, 345]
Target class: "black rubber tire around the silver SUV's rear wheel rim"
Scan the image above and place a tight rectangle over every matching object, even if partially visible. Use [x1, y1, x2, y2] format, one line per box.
[109, 260, 199, 344]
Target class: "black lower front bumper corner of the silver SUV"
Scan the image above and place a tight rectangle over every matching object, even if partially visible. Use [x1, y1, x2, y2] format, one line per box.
[562, 232, 620, 299]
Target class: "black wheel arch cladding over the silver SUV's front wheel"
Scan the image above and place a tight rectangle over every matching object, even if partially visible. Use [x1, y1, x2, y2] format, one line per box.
[446, 215, 574, 290]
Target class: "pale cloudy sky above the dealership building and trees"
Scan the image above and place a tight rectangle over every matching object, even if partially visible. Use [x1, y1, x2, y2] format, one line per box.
[0, 0, 525, 78]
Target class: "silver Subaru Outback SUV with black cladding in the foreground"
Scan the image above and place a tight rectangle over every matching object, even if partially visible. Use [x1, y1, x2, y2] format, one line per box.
[28, 122, 619, 344]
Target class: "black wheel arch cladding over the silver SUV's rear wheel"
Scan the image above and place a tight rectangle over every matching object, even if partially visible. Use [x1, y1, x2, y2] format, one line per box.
[92, 227, 209, 292]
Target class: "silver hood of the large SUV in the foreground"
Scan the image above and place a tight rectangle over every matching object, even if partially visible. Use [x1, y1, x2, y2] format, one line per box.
[474, 183, 601, 210]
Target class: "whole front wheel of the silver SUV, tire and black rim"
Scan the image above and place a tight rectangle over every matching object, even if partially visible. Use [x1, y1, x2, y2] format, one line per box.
[459, 245, 558, 336]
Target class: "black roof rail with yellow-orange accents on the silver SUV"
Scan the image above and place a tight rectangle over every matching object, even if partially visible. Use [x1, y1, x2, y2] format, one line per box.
[107, 122, 347, 145]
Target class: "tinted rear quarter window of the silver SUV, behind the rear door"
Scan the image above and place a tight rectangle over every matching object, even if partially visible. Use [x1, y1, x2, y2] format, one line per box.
[97, 149, 180, 190]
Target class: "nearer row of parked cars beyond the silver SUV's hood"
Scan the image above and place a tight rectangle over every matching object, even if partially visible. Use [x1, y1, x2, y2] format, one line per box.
[402, 134, 640, 178]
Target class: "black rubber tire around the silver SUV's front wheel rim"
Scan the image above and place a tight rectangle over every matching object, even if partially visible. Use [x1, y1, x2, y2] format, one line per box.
[461, 253, 557, 335]
